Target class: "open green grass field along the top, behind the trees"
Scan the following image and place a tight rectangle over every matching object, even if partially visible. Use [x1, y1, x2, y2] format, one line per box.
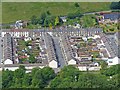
[2, 2, 111, 23]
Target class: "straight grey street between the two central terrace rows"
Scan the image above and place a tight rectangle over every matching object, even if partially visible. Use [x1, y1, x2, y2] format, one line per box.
[53, 36, 66, 68]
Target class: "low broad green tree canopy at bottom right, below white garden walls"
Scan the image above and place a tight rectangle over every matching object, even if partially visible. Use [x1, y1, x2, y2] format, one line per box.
[77, 73, 109, 88]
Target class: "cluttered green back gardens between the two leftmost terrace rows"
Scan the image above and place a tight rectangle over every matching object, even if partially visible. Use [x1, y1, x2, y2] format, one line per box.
[17, 39, 40, 63]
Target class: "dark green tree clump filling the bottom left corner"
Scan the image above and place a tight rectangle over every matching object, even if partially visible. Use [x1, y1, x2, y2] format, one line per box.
[2, 65, 55, 88]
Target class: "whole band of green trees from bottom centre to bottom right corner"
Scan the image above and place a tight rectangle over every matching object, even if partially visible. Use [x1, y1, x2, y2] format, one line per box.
[50, 66, 119, 88]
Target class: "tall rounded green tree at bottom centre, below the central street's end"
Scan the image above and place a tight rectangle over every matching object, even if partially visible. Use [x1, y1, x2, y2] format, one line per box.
[50, 65, 80, 88]
